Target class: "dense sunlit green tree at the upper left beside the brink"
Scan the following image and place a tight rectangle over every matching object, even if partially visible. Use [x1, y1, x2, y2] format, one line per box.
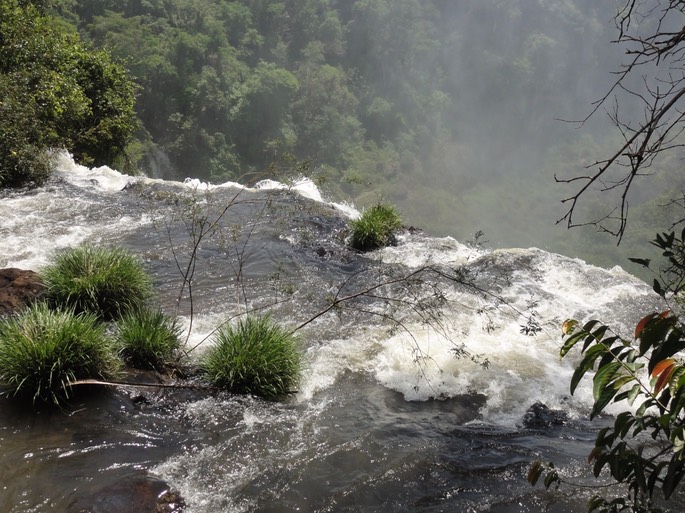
[0, 0, 137, 187]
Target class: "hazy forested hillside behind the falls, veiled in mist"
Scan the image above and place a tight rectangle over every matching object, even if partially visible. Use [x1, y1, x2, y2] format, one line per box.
[55, 0, 683, 272]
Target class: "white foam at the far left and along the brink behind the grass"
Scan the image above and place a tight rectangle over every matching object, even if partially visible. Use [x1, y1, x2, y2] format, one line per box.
[0, 152, 358, 269]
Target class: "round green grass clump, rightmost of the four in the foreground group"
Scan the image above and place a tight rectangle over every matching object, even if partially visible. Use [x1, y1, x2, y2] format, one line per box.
[201, 316, 301, 398]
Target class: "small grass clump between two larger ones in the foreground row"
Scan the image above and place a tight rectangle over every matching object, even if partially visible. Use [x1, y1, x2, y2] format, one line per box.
[116, 308, 181, 371]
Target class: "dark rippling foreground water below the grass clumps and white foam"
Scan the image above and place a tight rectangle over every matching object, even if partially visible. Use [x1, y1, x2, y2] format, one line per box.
[0, 364, 680, 513]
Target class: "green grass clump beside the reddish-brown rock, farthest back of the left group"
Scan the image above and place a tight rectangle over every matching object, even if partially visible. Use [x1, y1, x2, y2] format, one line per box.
[40, 244, 152, 320]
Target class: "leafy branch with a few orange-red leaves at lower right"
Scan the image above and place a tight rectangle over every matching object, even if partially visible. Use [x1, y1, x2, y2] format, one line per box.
[528, 311, 685, 512]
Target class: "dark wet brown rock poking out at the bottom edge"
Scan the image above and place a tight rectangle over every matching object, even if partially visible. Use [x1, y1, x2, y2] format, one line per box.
[67, 476, 185, 513]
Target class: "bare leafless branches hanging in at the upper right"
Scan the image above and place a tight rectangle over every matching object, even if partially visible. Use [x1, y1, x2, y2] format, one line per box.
[556, 0, 685, 242]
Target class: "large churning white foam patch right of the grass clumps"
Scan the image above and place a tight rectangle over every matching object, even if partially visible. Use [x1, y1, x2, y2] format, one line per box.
[292, 238, 659, 427]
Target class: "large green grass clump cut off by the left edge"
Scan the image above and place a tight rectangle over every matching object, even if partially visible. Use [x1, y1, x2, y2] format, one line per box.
[0, 303, 117, 404]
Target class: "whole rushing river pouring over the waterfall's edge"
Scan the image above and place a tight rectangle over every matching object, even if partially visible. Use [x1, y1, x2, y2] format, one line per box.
[0, 156, 680, 513]
